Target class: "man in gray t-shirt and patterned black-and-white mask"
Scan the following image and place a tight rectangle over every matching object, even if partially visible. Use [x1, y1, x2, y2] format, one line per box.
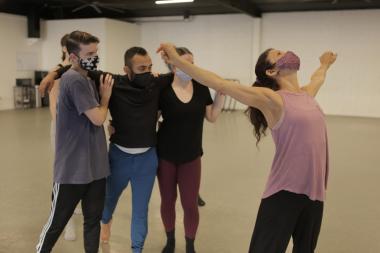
[36, 31, 113, 253]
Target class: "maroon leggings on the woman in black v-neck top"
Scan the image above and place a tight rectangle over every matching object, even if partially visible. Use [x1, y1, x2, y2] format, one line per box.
[157, 158, 201, 239]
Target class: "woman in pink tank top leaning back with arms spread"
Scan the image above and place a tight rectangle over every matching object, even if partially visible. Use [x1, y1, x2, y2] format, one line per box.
[158, 44, 337, 253]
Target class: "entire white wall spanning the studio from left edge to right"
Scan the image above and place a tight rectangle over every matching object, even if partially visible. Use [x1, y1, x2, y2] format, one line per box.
[0, 10, 380, 117]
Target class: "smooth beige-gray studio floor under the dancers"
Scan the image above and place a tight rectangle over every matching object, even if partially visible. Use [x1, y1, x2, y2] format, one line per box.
[0, 109, 380, 253]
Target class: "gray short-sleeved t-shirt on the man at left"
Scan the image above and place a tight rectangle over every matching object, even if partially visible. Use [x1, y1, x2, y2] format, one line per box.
[54, 69, 110, 184]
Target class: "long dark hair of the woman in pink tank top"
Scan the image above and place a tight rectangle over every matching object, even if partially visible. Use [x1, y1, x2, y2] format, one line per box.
[245, 48, 280, 145]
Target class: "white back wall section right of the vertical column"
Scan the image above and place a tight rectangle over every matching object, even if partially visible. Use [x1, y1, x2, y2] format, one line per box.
[261, 10, 380, 117]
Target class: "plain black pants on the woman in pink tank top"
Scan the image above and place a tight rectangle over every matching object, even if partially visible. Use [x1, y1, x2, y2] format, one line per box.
[249, 191, 323, 253]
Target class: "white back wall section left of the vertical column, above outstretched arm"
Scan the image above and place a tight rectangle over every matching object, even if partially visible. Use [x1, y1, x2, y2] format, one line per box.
[141, 15, 260, 108]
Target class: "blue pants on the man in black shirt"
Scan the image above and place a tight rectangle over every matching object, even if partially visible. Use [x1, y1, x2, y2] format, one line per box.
[102, 144, 158, 253]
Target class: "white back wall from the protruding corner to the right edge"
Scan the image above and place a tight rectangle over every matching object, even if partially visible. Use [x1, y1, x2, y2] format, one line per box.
[141, 10, 380, 117]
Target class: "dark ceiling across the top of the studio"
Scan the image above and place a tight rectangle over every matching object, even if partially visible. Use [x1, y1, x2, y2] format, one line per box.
[0, 0, 380, 19]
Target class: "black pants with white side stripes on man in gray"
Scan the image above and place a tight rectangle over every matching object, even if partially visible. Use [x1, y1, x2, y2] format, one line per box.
[36, 179, 106, 253]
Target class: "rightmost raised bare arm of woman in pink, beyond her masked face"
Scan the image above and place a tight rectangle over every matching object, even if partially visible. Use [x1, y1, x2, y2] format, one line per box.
[302, 52, 337, 97]
